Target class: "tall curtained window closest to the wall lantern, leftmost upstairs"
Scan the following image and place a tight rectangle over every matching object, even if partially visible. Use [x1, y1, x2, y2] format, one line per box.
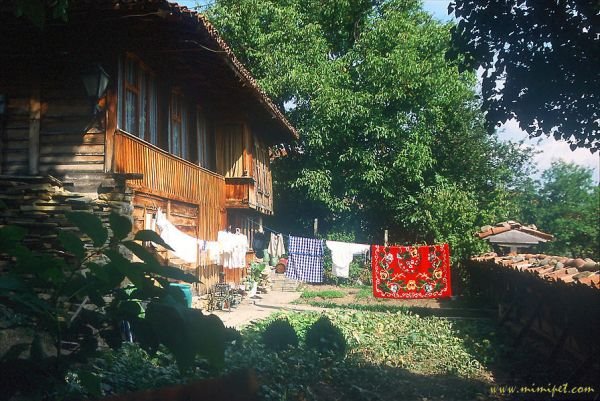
[120, 55, 158, 145]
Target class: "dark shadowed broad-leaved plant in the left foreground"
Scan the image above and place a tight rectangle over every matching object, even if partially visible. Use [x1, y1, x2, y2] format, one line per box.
[0, 212, 226, 399]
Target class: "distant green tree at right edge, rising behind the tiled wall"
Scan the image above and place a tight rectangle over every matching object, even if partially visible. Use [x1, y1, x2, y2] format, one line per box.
[535, 161, 600, 260]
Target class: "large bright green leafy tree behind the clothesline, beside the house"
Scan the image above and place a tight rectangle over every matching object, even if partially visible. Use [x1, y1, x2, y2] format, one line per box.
[209, 0, 527, 255]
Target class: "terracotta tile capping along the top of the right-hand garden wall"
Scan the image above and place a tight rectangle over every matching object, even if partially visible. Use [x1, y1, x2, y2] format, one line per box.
[473, 252, 600, 289]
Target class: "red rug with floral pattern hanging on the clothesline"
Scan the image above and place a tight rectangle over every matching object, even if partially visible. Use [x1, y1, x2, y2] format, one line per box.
[371, 244, 452, 299]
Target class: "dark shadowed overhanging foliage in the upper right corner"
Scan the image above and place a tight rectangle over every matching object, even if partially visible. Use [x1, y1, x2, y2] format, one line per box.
[449, 0, 600, 152]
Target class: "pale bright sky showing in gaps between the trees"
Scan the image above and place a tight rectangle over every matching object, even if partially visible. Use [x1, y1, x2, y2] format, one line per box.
[178, 0, 600, 183]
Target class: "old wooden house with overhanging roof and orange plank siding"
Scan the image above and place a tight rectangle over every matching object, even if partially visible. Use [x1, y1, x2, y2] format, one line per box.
[0, 0, 297, 292]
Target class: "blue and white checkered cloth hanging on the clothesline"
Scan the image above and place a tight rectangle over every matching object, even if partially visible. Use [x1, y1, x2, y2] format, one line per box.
[285, 235, 323, 283]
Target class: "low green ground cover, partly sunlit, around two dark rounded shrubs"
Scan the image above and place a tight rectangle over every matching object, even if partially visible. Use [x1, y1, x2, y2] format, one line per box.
[227, 309, 493, 401]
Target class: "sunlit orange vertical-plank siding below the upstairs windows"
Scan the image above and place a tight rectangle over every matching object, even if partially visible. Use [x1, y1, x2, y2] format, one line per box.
[114, 132, 225, 238]
